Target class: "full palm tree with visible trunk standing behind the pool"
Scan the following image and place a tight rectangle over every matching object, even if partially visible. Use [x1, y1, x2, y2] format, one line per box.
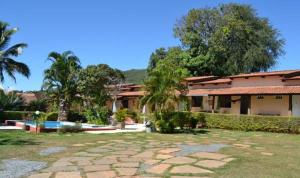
[42, 51, 81, 121]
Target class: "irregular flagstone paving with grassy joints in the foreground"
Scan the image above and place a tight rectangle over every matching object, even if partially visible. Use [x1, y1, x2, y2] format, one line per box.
[29, 140, 234, 178]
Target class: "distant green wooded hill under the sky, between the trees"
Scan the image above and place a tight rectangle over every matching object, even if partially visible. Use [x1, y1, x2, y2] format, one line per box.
[123, 69, 147, 84]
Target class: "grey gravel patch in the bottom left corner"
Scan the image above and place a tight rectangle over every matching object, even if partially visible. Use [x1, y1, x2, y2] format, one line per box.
[0, 159, 47, 178]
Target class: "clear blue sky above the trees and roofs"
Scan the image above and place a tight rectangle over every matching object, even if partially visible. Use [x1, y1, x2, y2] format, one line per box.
[0, 0, 300, 90]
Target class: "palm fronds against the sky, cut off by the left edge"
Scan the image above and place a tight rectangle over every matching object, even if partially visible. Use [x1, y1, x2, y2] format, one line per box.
[0, 21, 30, 82]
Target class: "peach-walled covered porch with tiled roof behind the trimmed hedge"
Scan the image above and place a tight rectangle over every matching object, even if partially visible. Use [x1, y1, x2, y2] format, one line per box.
[188, 86, 300, 116]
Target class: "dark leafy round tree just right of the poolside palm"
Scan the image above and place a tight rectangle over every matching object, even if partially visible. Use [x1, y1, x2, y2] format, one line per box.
[78, 64, 125, 107]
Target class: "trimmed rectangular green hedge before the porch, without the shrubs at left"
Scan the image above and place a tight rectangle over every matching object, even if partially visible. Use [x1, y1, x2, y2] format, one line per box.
[193, 113, 300, 133]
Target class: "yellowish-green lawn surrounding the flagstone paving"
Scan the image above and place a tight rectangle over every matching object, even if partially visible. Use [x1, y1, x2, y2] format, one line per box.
[0, 129, 300, 177]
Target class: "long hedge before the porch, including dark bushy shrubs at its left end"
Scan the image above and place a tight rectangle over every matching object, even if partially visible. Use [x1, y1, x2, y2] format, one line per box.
[153, 112, 300, 133]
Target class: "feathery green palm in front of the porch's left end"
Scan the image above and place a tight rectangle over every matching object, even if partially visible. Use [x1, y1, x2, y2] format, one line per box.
[141, 59, 188, 112]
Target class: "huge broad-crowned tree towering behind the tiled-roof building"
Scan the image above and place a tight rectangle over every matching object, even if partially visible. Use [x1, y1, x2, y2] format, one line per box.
[174, 3, 284, 76]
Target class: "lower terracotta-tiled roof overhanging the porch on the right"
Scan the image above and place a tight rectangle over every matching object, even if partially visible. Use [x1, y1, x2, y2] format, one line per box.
[187, 86, 300, 96]
